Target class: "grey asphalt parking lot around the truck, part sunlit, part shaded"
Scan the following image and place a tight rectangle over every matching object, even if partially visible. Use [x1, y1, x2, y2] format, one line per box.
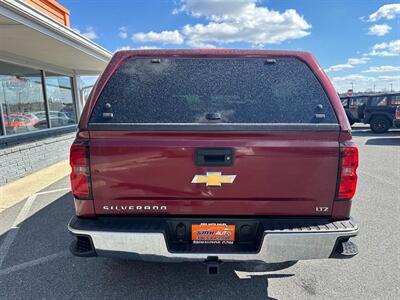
[0, 126, 400, 299]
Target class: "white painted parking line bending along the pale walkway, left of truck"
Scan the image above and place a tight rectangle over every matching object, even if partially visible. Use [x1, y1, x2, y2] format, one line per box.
[0, 188, 69, 270]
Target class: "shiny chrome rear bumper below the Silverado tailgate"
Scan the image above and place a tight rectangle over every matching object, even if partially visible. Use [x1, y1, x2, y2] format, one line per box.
[68, 219, 358, 263]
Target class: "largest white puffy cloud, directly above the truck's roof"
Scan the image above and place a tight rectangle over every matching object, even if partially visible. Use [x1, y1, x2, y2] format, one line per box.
[134, 0, 311, 48]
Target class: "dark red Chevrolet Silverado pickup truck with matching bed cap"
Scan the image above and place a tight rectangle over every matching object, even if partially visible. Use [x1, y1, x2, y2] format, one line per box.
[68, 50, 358, 270]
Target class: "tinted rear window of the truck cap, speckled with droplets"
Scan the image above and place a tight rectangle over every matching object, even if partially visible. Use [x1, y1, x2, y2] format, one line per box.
[90, 58, 337, 124]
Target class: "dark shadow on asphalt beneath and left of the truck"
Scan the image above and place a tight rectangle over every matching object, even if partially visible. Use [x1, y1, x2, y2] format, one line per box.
[0, 193, 294, 299]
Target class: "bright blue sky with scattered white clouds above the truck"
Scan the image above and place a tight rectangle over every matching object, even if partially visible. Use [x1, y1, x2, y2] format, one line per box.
[58, 0, 400, 92]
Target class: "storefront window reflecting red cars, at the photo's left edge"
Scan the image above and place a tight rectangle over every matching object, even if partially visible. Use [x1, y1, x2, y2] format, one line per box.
[0, 61, 47, 135]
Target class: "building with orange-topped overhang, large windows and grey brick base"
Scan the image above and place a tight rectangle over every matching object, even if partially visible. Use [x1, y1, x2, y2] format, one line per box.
[0, 0, 111, 185]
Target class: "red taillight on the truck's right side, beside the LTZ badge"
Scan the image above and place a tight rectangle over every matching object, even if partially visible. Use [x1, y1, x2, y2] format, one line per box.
[338, 145, 358, 200]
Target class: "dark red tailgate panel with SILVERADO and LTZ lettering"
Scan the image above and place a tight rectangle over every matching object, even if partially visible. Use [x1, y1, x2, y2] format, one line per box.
[89, 131, 339, 216]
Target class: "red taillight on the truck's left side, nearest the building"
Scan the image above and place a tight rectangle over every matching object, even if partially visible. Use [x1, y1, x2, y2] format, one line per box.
[69, 143, 91, 199]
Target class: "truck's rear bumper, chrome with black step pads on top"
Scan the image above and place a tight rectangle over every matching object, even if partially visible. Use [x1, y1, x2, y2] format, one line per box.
[68, 217, 358, 263]
